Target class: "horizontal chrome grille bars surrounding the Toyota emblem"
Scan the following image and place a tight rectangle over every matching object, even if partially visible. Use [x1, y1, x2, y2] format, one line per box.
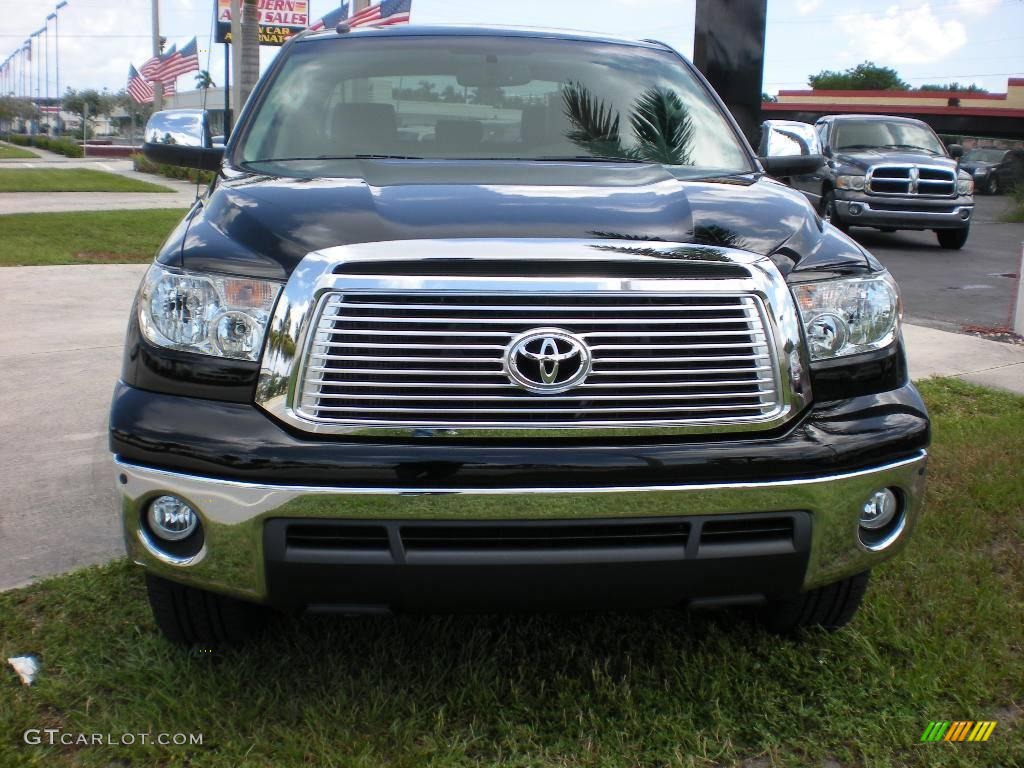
[294, 291, 782, 429]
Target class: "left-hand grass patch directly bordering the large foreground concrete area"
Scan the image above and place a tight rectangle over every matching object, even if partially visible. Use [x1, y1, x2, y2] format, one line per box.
[0, 210, 185, 266]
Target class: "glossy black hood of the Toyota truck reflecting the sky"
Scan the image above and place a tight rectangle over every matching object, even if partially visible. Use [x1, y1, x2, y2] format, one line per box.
[174, 160, 877, 280]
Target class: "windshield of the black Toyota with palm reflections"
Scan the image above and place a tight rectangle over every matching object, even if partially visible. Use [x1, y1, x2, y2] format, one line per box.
[234, 36, 753, 176]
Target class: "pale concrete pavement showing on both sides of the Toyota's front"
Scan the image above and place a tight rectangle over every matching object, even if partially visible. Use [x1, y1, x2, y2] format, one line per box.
[0, 264, 1024, 591]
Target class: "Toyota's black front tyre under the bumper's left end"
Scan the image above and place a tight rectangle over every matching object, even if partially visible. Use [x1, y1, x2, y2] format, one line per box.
[145, 573, 267, 646]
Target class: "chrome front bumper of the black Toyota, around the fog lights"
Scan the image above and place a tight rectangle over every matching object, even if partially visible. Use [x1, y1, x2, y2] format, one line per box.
[115, 451, 927, 602]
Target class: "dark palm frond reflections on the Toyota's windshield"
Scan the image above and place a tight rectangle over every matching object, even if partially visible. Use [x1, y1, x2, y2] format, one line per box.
[562, 82, 694, 165]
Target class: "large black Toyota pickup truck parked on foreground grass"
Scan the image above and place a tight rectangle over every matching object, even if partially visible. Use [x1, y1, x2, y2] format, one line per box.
[116, 27, 929, 643]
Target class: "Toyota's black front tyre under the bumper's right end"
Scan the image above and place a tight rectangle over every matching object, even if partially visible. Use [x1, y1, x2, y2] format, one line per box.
[761, 570, 871, 635]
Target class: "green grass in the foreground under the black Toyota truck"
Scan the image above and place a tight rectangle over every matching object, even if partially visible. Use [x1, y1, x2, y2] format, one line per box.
[0, 380, 1024, 768]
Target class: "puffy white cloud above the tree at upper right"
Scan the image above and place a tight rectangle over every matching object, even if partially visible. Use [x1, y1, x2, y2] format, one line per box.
[837, 3, 967, 65]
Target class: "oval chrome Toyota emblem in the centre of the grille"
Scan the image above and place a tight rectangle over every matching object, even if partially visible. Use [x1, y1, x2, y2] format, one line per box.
[503, 328, 591, 394]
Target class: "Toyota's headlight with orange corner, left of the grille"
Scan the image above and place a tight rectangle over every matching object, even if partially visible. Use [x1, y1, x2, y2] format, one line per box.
[138, 264, 281, 360]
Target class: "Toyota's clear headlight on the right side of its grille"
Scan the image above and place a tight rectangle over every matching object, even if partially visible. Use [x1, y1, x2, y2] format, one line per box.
[793, 272, 903, 360]
